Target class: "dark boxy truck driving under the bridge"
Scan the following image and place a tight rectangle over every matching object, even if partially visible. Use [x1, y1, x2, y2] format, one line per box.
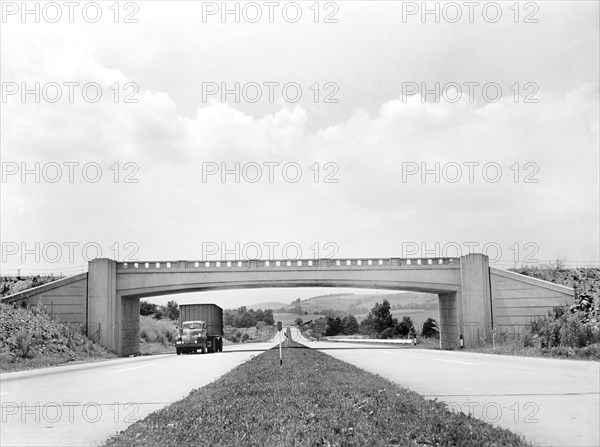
[175, 304, 223, 355]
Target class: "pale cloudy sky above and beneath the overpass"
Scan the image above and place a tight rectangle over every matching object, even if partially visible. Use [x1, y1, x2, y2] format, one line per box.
[0, 1, 600, 305]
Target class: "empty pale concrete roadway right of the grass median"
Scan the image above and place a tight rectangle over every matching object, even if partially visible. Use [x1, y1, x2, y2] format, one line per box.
[292, 329, 600, 446]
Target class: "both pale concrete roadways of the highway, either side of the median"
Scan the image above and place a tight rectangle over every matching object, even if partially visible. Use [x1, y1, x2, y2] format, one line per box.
[0, 328, 600, 446]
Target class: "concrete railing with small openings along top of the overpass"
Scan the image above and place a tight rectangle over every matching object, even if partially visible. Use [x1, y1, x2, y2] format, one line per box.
[117, 258, 460, 270]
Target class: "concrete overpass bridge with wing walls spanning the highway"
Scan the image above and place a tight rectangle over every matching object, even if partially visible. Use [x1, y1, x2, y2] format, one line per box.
[2, 254, 574, 356]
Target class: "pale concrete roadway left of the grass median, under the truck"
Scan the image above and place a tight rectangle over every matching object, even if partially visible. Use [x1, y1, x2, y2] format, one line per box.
[0, 343, 274, 446]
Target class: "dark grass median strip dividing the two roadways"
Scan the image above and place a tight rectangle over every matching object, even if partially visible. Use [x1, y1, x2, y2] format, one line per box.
[104, 342, 530, 447]
